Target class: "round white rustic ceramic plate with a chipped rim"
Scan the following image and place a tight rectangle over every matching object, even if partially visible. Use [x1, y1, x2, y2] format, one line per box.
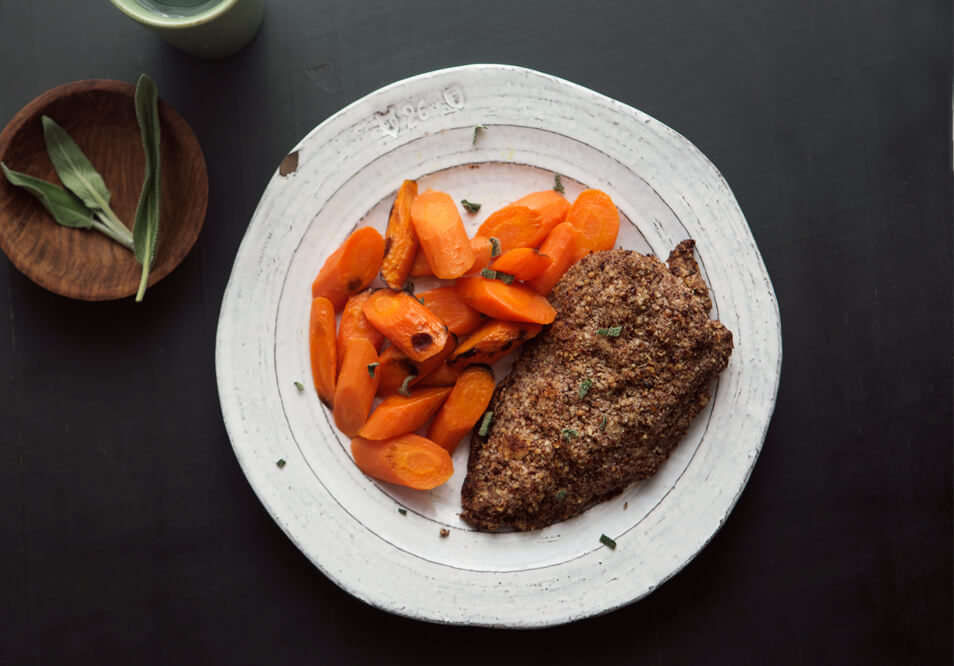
[216, 65, 781, 627]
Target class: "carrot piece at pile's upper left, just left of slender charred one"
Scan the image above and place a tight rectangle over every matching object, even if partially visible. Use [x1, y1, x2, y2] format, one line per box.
[311, 227, 384, 310]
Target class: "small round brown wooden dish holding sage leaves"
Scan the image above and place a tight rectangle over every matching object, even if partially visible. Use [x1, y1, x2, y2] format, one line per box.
[0, 79, 209, 301]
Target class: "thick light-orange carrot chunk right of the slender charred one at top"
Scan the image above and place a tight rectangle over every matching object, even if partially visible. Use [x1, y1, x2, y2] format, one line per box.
[411, 190, 474, 280]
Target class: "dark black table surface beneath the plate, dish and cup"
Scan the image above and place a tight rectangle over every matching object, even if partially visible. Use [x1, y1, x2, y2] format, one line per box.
[0, 0, 954, 664]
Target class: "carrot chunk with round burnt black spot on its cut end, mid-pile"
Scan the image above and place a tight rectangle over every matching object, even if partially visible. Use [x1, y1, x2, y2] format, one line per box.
[364, 289, 447, 361]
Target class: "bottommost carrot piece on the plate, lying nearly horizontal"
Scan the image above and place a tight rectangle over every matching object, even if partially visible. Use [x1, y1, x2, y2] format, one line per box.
[351, 434, 454, 490]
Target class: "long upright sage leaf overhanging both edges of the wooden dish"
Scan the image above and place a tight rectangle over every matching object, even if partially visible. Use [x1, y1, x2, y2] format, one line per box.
[133, 74, 161, 302]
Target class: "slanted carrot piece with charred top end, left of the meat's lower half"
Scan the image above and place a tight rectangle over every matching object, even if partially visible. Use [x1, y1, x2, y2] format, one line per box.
[427, 365, 494, 453]
